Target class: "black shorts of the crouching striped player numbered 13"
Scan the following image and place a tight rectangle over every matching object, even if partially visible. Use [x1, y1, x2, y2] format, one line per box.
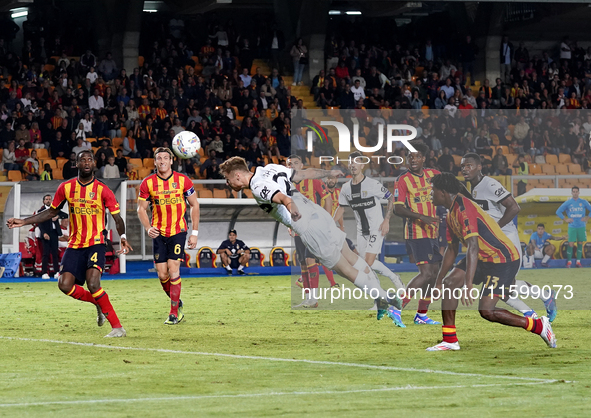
[456, 257, 521, 297]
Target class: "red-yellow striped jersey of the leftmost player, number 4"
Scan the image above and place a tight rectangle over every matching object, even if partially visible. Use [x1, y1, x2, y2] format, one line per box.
[51, 178, 120, 248]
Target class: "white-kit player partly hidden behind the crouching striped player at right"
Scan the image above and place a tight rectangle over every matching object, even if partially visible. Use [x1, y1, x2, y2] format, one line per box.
[450, 153, 557, 322]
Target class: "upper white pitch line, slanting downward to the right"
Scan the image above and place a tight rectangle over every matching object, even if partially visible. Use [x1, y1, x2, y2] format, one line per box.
[0, 336, 557, 383]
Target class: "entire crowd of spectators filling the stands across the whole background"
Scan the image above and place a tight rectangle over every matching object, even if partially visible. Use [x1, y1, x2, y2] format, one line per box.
[0, 10, 591, 185]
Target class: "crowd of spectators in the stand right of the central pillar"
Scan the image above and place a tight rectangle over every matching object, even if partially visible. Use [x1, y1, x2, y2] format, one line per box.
[310, 36, 591, 173]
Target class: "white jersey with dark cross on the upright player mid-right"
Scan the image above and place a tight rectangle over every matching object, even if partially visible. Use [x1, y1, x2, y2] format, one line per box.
[339, 177, 392, 236]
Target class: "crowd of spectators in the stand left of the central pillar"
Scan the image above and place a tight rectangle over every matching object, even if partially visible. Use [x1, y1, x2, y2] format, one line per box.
[0, 18, 301, 180]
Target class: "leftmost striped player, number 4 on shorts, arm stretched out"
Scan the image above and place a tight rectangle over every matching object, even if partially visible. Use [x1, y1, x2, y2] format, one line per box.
[7, 151, 133, 337]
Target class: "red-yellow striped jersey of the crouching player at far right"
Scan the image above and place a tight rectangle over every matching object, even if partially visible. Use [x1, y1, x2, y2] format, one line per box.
[447, 194, 519, 264]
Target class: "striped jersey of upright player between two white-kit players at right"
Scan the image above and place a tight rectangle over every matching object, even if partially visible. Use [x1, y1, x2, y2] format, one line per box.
[394, 168, 441, 239]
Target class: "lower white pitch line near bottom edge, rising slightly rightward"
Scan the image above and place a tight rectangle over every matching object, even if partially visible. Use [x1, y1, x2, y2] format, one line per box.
[0, 381, 552, 408]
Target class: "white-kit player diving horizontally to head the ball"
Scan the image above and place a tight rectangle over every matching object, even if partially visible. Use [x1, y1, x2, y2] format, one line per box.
[220, 157, 402, 319]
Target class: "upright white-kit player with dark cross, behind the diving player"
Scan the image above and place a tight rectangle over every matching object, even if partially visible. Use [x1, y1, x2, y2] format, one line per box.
[335, 151, 405, 318]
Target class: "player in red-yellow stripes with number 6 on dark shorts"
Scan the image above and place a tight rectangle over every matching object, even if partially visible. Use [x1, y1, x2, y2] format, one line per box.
[137, 147, 199, 325]
